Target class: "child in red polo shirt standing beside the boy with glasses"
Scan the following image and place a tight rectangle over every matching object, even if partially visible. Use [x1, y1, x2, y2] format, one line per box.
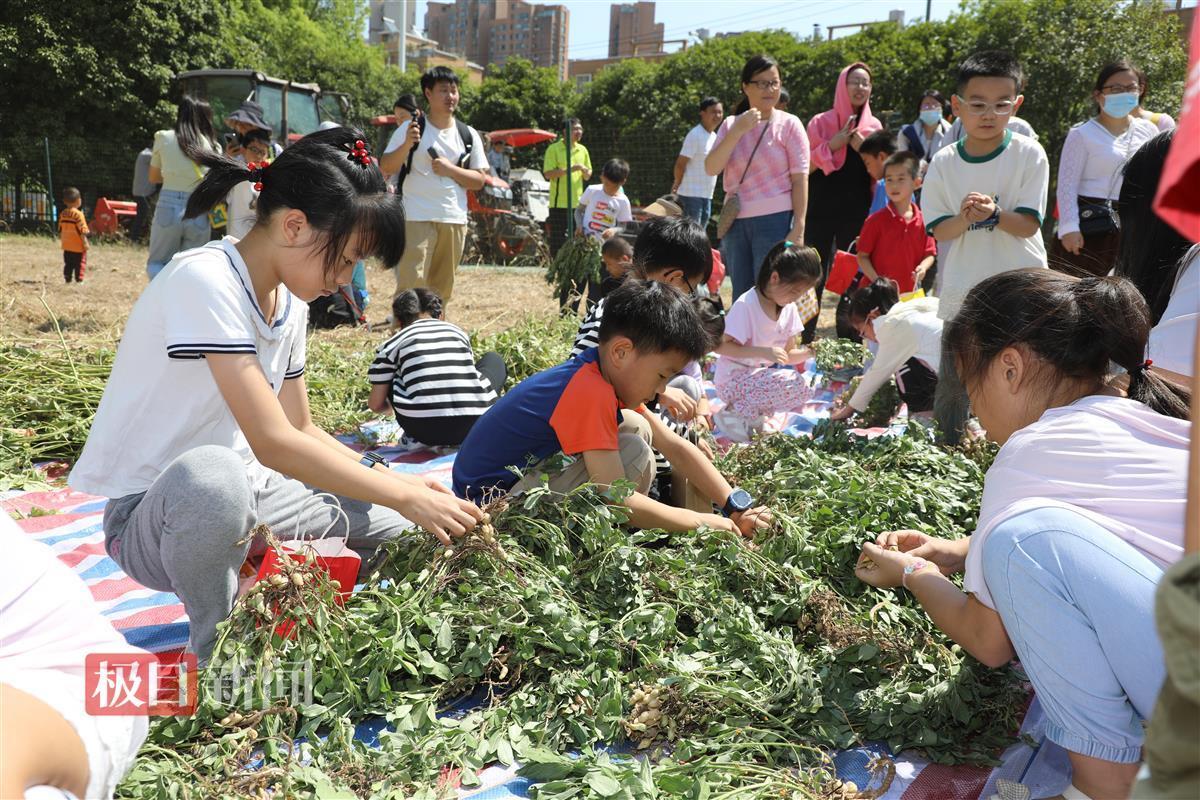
[858, 151, 937, 295]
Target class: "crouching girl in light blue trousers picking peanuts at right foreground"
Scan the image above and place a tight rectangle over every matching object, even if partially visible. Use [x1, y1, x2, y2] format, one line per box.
[856, 269, 1190, 799]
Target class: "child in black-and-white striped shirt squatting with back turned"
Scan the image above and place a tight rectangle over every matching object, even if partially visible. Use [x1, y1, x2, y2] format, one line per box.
[367, 289, 508, 447]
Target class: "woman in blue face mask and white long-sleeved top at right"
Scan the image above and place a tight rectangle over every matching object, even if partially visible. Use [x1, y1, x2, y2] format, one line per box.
[1050, 61, 1158, 275]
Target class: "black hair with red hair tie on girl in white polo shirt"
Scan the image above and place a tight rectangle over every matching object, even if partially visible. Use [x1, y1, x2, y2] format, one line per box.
[184, 127, 404, 275]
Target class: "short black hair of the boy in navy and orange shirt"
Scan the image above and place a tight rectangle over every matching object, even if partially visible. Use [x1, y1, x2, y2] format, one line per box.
[600, 278, 709, 360]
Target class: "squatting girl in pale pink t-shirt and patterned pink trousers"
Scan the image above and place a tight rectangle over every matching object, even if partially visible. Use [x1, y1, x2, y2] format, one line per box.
[715, 241, 821, 427]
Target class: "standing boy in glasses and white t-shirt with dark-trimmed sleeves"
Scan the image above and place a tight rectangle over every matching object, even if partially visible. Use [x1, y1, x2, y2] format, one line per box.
[922, 50, 1050, 444]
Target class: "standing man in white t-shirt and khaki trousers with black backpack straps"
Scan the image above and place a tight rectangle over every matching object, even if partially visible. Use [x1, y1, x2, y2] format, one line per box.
[379, 67, 487, 302]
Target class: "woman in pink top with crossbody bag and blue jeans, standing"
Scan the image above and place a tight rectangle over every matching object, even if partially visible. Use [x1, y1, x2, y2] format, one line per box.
[704, 55, 809, 297]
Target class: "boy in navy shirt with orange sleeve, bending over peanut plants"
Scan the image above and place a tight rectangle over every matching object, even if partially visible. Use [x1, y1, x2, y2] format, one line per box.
[454, 278, 770, 536]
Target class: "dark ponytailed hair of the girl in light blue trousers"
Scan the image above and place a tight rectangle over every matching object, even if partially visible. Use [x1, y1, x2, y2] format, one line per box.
[942, 269, 1190, 420]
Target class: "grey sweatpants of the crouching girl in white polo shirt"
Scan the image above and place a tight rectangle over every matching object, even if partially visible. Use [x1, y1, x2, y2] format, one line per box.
[104, 445, 413, 663]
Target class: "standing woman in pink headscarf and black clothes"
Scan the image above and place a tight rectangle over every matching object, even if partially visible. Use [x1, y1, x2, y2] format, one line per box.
[803, 61, 883, 344]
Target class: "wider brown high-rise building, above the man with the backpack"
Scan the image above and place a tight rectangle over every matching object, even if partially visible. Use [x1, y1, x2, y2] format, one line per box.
[425, 0, 570, 78]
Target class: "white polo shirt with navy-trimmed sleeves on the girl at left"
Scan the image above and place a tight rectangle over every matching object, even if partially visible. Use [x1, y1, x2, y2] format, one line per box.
[68, 236, 308, 498]
